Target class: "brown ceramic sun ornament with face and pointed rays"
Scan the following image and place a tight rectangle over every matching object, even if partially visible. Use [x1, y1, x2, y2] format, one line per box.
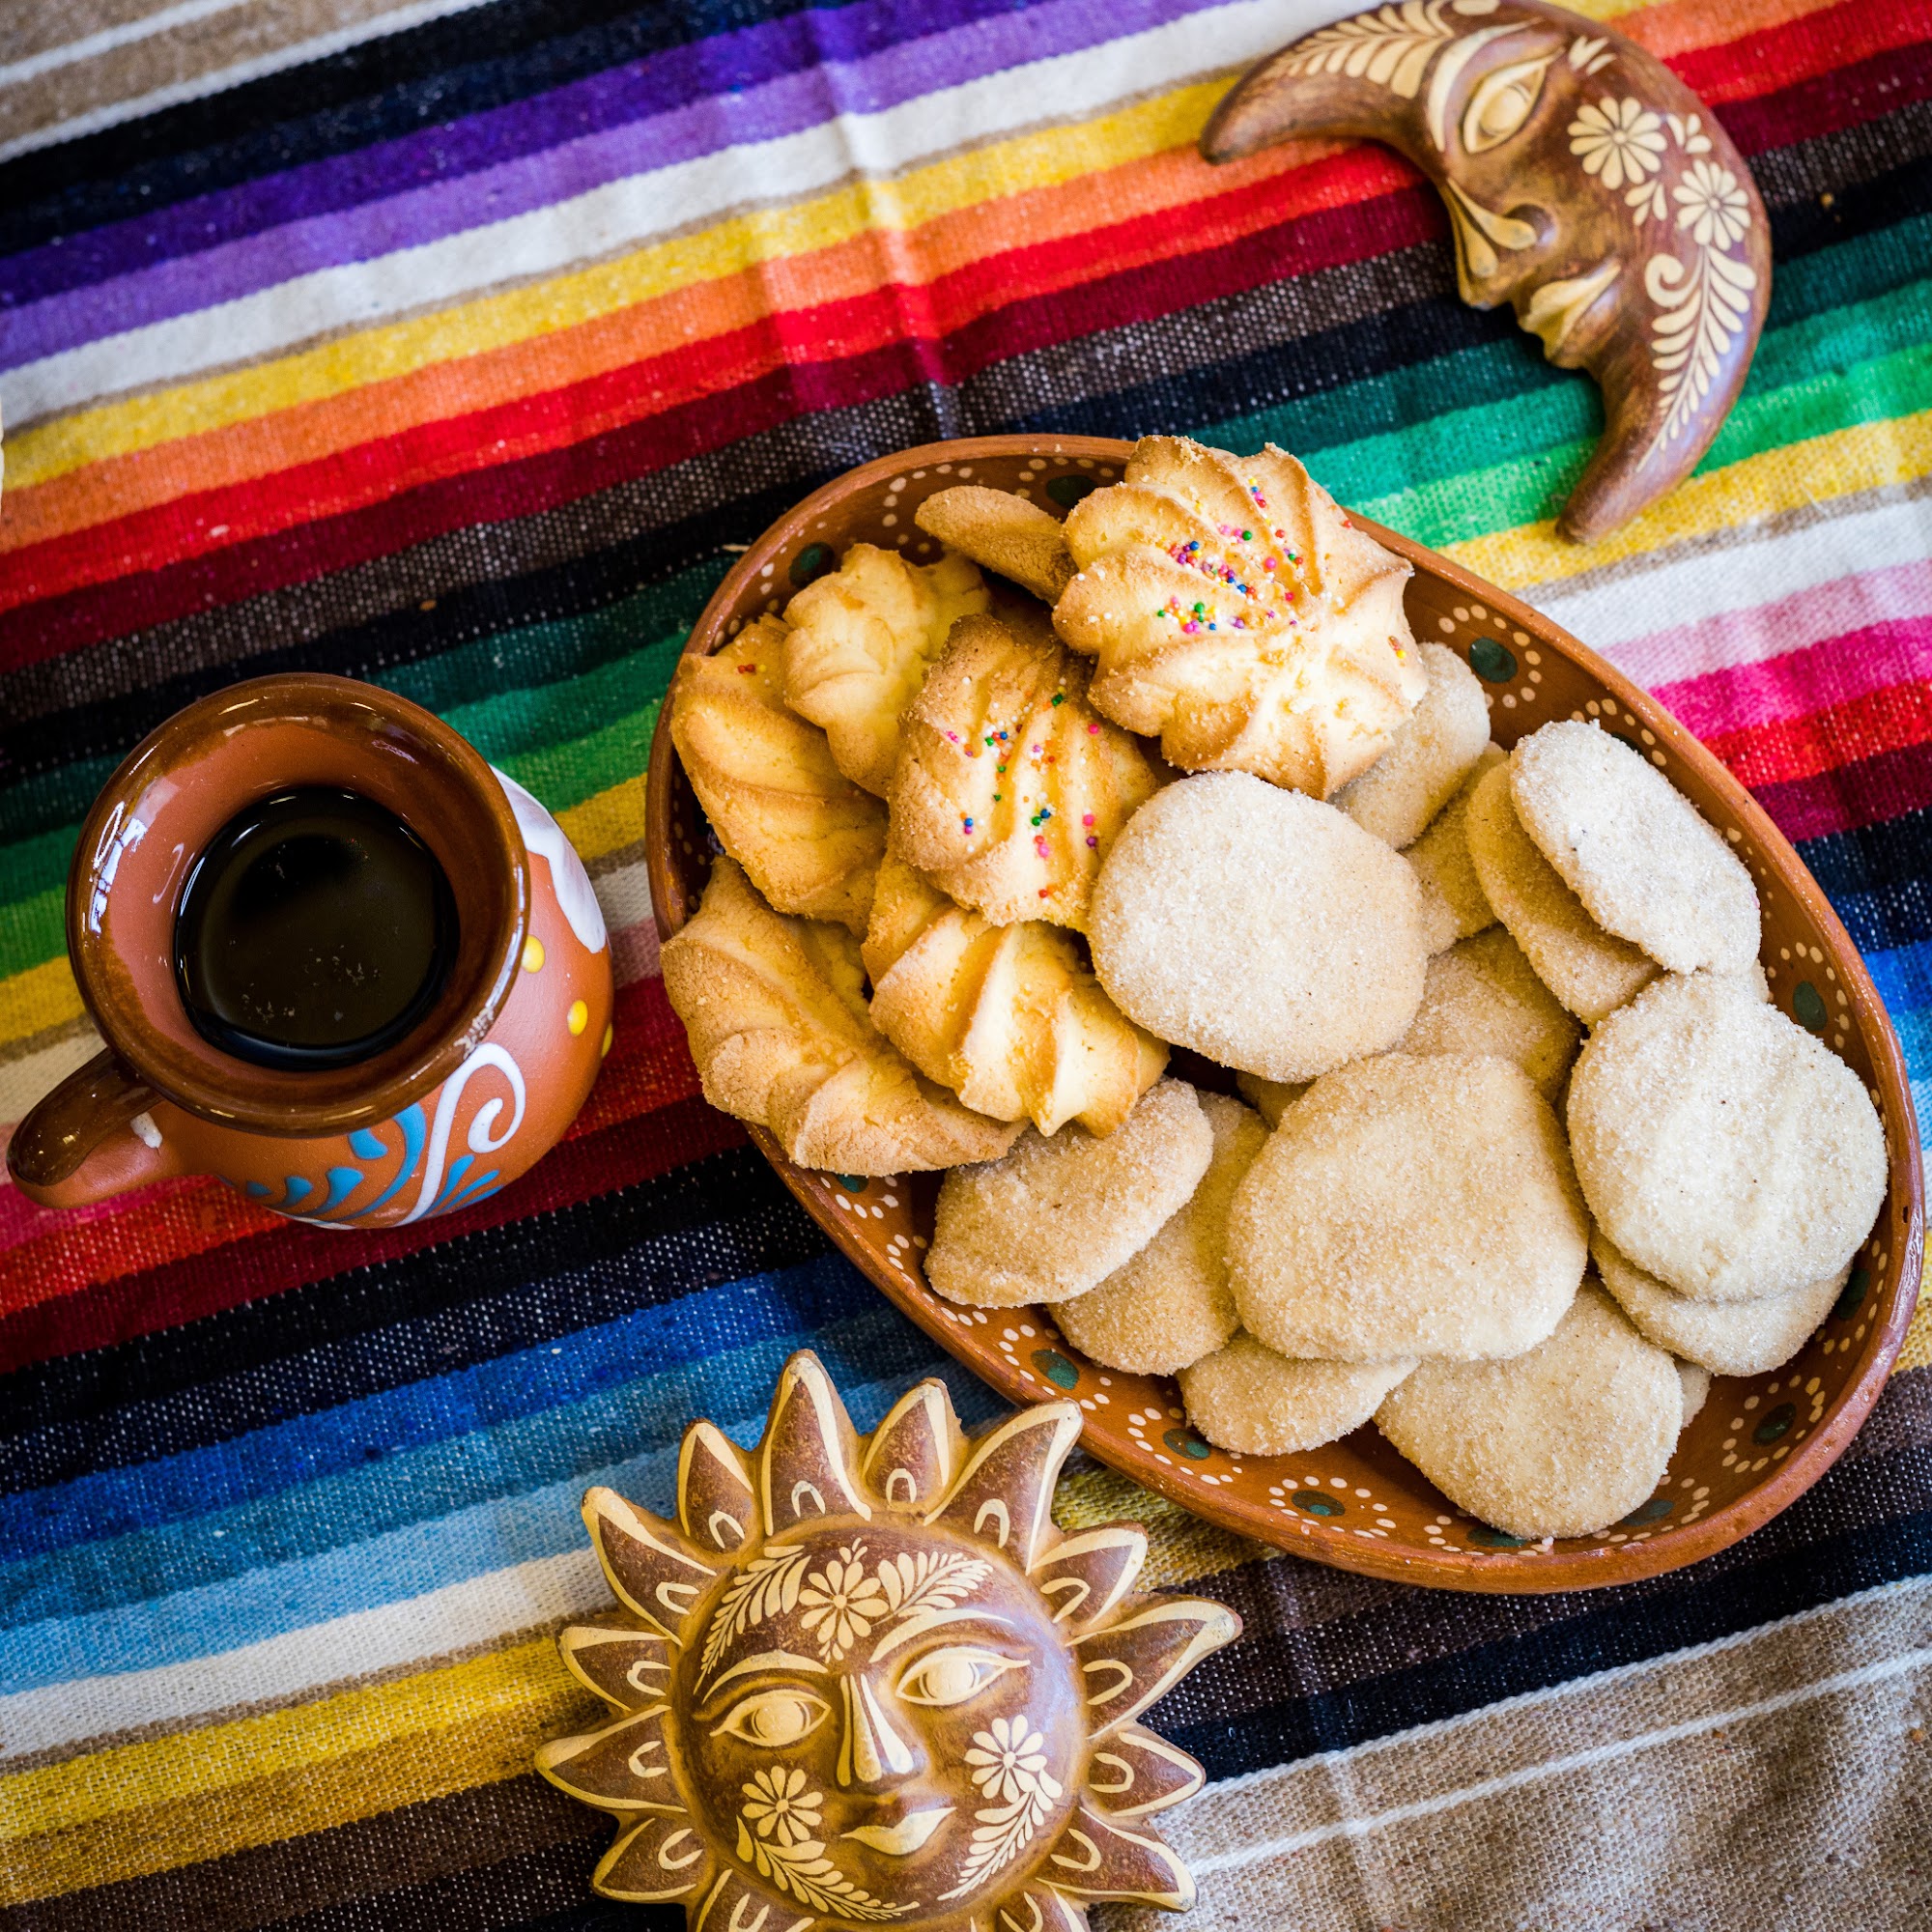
[537, 1354, 1240, 1932]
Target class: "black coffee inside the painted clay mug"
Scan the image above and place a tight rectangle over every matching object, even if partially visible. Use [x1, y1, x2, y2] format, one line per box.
[174, 784, 458, 1068]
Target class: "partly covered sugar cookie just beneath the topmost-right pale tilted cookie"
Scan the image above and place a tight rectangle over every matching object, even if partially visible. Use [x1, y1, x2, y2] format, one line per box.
[1464, 765, 1658, 1026]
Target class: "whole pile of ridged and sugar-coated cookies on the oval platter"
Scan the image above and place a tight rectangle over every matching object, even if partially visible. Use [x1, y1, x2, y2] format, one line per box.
[665, 437, 1886, 1538]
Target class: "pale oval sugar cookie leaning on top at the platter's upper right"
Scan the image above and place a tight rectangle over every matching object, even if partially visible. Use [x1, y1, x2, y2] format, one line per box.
[1509, 719, 1758, 972]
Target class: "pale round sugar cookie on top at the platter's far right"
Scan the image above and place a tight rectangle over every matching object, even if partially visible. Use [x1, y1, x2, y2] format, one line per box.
[1567, 974, 1886, 1302]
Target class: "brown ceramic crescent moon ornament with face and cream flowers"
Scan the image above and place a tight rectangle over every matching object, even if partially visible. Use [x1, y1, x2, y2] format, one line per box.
[1202, 0, 1772, 543]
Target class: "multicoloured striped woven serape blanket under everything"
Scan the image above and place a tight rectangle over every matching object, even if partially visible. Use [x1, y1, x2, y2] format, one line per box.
[0, 0, 1932, 1932]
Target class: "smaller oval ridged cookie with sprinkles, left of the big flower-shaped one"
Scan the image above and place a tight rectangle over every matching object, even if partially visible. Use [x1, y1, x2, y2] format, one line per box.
[887, 616, 1157, 931]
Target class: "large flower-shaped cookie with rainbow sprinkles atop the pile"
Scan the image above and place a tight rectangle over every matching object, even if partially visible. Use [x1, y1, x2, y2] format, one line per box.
[1053, 437, 1426, 798]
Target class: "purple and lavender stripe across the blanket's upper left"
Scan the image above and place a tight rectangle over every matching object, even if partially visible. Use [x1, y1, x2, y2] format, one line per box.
[0, 0, 1219, 369]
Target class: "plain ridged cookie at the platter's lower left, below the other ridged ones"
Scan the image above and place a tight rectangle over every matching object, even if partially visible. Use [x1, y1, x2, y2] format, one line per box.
[663, 858, 1018, 1175]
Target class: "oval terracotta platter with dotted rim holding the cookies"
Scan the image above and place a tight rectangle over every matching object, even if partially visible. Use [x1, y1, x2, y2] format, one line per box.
[645, 437, 1924, 1592]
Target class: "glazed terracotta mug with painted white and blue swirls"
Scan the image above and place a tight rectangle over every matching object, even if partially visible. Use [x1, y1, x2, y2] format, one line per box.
[8, 674, 612, 1229]
